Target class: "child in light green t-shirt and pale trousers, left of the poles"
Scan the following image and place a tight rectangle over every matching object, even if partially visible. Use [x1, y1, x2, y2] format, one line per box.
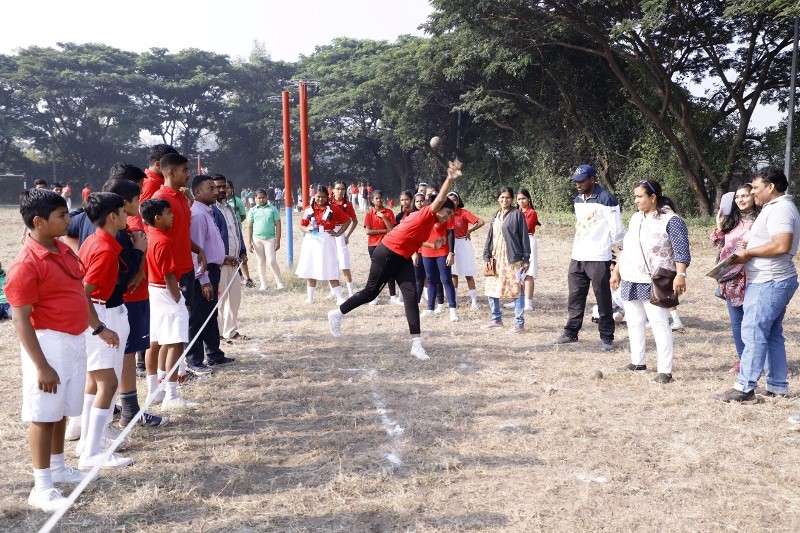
[247, 189, 283, 291]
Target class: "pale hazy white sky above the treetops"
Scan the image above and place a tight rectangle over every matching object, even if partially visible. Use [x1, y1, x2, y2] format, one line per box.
[0, 0, 785, 129]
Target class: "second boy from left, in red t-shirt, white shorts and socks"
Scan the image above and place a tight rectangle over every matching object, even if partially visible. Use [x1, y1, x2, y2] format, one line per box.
[78, 192, 133, 469]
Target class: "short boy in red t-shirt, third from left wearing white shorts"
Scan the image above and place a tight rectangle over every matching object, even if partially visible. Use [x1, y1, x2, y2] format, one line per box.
[139, 198, 199, 411]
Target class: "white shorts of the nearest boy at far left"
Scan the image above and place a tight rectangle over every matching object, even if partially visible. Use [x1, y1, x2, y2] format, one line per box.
[20, 329, 86, 422]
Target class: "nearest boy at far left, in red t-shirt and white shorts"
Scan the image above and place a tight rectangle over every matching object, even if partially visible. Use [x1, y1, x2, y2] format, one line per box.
[5, 189, 89, 512]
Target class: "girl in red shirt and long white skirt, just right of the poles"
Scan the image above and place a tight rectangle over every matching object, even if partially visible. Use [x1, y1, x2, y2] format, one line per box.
[296, 185, 350, 304]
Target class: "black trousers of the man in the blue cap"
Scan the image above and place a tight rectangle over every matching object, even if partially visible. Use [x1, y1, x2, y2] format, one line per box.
[564, 259, 616, 340]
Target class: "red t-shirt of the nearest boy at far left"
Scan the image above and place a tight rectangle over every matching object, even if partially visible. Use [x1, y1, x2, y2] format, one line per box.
[5, 236, 89, 335]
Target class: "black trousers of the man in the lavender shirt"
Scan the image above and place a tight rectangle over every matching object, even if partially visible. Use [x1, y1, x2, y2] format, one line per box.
[186, 264, 225, 366]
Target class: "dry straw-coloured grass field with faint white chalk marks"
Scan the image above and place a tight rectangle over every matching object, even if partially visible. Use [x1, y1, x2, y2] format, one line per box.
[0, 202, 800, 532]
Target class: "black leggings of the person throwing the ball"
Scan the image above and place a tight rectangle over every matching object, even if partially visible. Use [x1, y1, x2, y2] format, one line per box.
[339, 243, 419, 335]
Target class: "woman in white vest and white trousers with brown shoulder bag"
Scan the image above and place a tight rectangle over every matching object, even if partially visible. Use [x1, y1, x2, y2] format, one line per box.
[611, 180, 691, 383]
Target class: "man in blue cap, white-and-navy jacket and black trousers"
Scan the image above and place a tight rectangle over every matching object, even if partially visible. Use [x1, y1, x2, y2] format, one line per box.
[553, 165, 625, 351]
